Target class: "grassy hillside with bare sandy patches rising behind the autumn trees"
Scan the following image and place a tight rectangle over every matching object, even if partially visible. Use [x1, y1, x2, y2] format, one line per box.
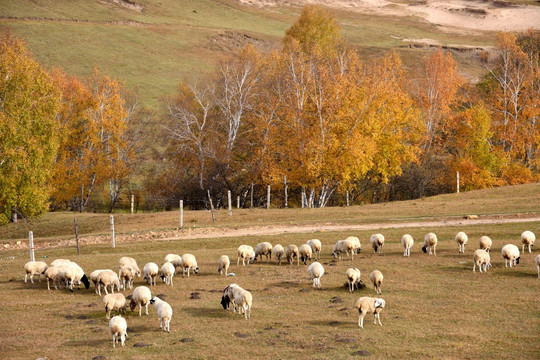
[0, 0, 540, 108]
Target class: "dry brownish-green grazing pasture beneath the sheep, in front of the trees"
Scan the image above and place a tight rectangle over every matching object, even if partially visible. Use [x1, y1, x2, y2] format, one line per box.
[0, 184, 540, 359]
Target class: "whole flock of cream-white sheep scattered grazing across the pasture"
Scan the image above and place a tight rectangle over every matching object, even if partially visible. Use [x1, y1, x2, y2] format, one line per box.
[20, 231, 540, 347]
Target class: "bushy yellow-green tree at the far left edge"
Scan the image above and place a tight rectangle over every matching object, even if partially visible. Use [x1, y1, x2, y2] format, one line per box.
[0, 33, 60, 224]
